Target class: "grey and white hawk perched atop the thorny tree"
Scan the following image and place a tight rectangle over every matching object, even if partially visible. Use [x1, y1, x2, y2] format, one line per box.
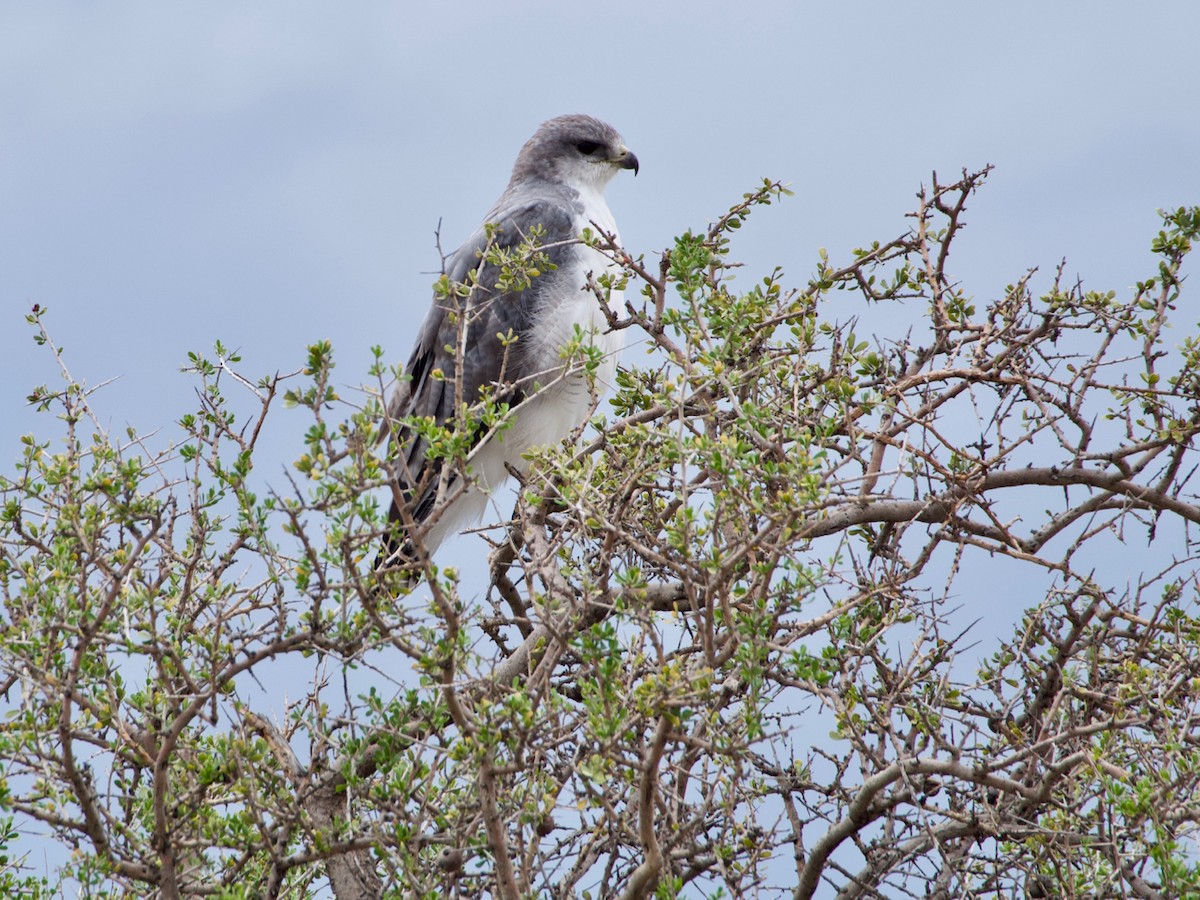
[376, 115, 637, 578]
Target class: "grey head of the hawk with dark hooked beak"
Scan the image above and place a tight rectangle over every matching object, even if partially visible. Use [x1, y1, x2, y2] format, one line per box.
[509, 115, 637, 191]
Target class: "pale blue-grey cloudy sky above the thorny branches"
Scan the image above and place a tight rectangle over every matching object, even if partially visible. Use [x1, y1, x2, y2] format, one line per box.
[0, 1, 1200, 564]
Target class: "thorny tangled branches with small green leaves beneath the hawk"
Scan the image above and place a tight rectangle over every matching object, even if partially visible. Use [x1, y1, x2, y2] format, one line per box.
[0, 170, 1200, 900]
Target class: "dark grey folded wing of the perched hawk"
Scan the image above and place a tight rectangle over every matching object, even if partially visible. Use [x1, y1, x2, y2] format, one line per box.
[388, 194, 578, 528]
